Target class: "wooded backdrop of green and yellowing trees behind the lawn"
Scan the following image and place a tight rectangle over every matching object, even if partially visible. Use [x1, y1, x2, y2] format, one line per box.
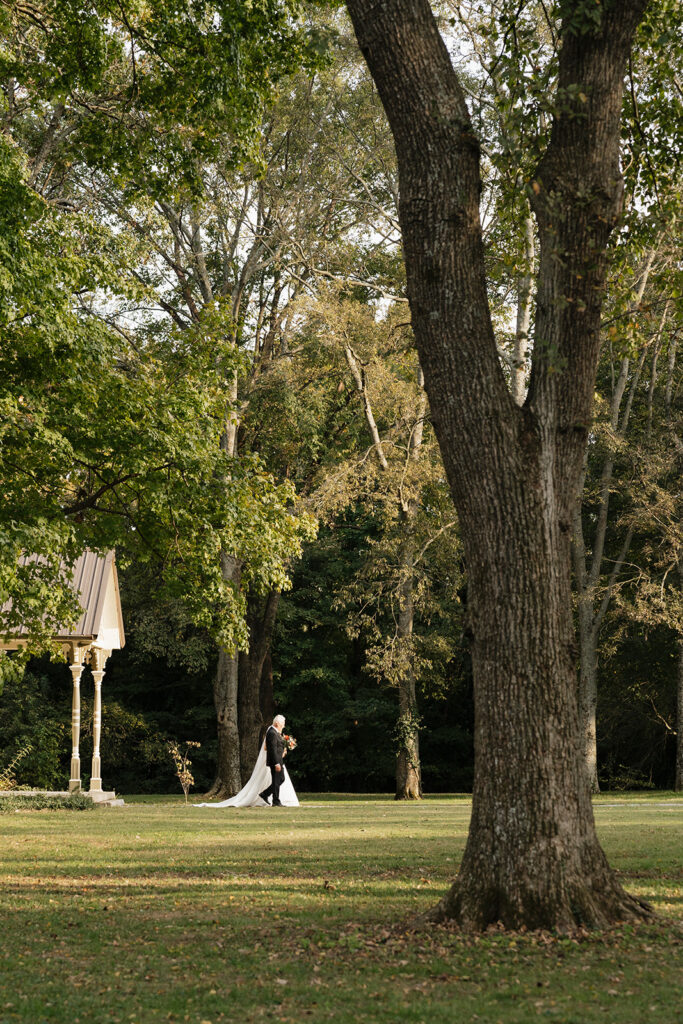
[0, 4, 683, 796]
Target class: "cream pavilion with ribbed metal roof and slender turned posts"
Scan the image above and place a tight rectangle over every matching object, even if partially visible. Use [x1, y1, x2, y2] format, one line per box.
[0, 551, 126, 802]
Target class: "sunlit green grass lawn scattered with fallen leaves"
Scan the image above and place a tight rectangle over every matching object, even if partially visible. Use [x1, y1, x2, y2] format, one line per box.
[0, 794, 683, 1024]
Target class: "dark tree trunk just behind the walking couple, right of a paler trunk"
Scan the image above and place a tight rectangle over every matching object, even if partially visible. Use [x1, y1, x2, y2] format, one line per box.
[239, 591, 280, 785]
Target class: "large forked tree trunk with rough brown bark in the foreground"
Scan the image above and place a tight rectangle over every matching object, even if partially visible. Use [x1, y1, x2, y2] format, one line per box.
[347, 0, 647, 930]
